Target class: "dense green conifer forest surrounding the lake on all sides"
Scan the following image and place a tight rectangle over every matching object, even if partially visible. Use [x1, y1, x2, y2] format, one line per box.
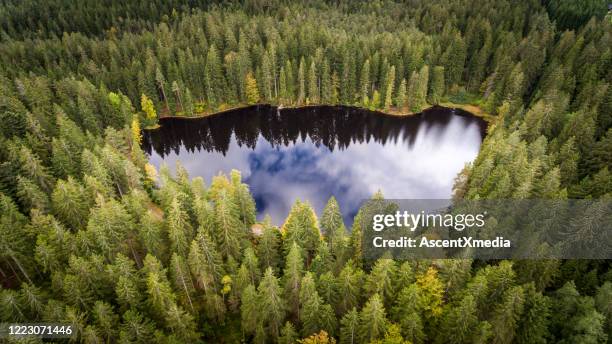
[0, 0, 612, 344]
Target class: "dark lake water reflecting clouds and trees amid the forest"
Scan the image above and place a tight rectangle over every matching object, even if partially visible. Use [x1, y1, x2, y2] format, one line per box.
[143, 106, 486, 225]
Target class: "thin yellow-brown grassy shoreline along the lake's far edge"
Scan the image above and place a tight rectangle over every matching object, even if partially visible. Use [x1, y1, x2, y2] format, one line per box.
[144, 102, 496, 130]
